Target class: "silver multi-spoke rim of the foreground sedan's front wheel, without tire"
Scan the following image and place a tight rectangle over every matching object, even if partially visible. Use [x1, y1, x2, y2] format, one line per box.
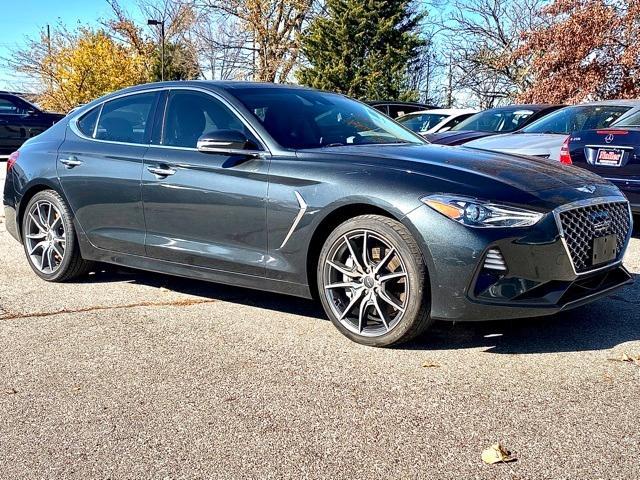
[323, 229, 410, 337]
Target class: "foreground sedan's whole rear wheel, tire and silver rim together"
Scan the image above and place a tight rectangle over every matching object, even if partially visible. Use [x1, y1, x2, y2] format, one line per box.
[22, 190, 91, 282]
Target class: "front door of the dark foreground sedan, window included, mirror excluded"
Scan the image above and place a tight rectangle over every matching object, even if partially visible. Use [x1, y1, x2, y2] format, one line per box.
[142, 89, 269, 276]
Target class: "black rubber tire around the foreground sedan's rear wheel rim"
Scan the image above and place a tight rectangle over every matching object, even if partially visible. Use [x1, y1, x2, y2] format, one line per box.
[22, 190, 93, 282]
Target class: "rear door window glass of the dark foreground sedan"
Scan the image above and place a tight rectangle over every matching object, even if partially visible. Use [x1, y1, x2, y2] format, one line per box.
[95, 92, 156, 144]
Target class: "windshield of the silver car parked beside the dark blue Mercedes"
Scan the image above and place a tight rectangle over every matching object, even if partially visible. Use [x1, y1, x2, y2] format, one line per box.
[522, 105, 631, 135]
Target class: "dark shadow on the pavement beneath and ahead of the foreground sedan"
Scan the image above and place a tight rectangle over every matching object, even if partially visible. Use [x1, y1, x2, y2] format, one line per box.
[77, 266, 640, 354]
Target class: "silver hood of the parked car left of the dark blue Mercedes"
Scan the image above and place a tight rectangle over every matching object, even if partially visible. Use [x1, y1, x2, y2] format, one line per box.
[465, 133, 567, 160]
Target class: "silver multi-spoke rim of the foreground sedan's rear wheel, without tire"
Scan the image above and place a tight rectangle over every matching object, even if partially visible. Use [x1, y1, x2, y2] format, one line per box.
[24, 200, 66, 275]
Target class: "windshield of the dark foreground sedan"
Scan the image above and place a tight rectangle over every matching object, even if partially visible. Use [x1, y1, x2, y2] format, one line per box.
[230, 87, 426, 149]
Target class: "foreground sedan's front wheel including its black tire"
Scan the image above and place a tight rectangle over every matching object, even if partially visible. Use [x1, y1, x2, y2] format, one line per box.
[317, 215, 433, 347]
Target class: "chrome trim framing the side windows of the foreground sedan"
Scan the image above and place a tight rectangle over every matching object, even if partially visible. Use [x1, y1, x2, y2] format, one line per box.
[69, 86, 271, 155]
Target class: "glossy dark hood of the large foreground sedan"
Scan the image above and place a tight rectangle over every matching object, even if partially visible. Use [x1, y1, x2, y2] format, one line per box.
[299, 145, 619, 207]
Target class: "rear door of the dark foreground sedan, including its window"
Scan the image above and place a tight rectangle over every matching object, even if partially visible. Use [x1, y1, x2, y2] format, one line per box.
[57, 92, 158, 255]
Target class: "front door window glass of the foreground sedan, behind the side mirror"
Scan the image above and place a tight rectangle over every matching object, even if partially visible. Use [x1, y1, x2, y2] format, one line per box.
[161, 90, 258, 148]
